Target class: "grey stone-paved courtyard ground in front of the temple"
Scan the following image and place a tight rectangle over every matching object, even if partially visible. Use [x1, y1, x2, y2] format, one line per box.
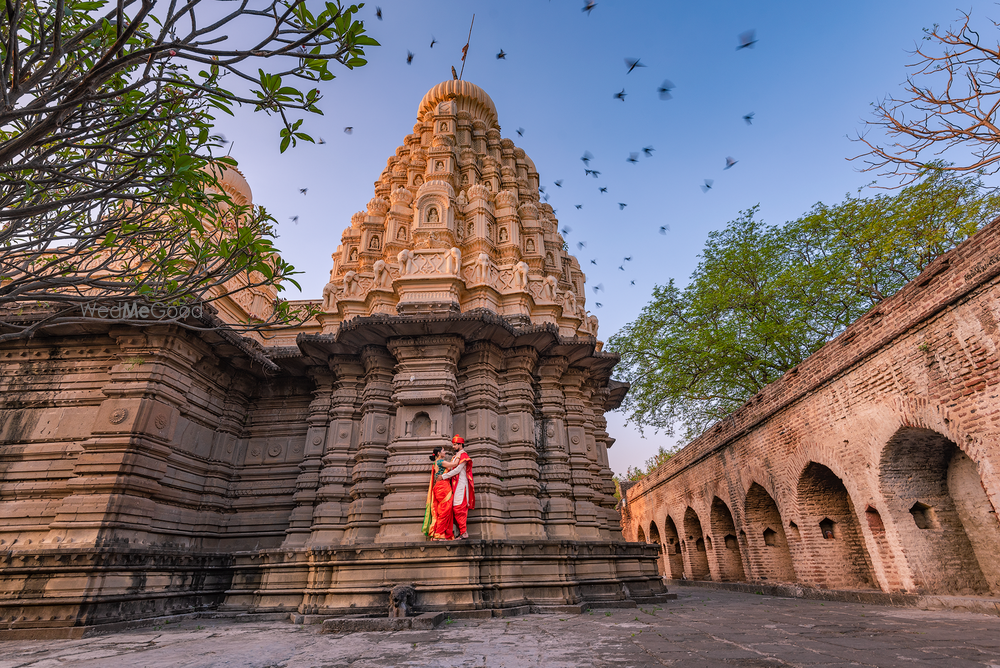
[0, 590, 1000, 668]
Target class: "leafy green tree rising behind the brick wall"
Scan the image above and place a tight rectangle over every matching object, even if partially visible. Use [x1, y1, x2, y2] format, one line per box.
[608, 170, 1000, 438]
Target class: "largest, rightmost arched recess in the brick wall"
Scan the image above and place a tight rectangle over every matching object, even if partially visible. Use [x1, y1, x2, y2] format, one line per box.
[879, 427, 1000, 595]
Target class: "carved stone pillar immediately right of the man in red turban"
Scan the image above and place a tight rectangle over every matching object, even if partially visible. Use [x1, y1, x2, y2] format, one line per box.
[456, 341, 508, 540]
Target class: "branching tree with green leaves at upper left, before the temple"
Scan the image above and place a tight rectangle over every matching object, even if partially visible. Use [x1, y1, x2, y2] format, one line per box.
[0, 0, 377, 340]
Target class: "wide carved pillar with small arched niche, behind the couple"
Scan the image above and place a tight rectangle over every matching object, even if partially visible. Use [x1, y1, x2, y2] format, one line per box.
[375, 335, 464, 543]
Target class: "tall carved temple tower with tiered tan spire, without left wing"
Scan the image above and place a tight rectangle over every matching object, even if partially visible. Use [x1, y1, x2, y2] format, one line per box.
[223, 80, 663, 612]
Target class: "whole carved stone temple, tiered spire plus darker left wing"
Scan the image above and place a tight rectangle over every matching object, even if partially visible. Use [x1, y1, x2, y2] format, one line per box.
[0, 80, 665, 637]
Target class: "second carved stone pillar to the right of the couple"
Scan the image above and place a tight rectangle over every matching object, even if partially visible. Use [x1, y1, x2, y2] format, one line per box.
[500, 346, 545, 539]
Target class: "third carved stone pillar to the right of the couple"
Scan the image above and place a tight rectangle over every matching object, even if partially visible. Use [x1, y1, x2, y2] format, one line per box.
[535, 357, 576, 540]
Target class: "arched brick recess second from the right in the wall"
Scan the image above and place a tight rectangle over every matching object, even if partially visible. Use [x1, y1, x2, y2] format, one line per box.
[798, 462, 875, 589]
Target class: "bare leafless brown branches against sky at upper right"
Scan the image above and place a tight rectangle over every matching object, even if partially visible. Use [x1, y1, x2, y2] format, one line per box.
[859, 12, 1000, 184]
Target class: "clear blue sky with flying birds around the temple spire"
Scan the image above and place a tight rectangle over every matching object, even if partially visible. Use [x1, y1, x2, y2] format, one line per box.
[219, 0, 1000, 473]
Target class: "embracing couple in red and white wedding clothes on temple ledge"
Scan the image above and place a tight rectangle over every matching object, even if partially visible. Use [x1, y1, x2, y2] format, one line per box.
[423, 434, 476, 540]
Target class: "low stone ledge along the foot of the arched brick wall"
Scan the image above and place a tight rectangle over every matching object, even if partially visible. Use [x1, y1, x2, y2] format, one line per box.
[663, 578, 1000, 616]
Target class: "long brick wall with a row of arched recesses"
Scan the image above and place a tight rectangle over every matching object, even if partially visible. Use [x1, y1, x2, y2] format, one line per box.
[622, 214, 1000, 596]
